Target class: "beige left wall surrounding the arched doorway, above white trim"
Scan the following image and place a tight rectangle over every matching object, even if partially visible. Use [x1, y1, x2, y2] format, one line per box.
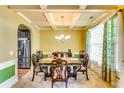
[0, 6, 40, 63]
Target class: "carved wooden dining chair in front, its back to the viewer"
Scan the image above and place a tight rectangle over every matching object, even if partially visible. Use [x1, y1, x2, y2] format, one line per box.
[51, 58, 68, 88]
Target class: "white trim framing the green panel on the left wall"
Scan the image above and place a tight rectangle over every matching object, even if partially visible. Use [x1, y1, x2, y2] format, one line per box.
[0, 59, 18, 88]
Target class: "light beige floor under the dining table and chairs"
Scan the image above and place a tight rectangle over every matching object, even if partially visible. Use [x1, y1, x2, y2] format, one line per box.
[13, 69, 112, 88]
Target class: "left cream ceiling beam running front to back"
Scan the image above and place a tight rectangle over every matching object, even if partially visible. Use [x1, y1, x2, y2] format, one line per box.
[40, 5, 56, 31]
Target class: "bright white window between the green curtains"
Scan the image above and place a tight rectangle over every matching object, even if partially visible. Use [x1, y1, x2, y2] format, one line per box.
[90, 24, 104, 66]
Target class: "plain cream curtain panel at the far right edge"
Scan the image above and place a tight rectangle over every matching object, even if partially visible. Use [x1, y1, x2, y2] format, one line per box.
[116, 11, 124, 74]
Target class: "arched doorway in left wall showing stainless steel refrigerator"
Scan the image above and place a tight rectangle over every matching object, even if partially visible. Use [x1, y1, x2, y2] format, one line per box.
[18, 24, 31, 69]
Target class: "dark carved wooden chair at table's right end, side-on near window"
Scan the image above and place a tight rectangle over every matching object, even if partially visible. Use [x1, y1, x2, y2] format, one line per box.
[75, 54, 89, 80]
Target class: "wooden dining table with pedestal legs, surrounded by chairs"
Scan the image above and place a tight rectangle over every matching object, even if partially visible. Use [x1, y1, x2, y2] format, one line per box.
[39, 57, 83, 80]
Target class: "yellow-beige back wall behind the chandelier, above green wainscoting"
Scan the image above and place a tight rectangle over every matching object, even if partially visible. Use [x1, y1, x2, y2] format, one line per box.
[41, 30, 86, 52]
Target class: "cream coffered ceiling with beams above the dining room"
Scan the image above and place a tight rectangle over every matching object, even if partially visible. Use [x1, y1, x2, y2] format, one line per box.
[8, 5, 117, 30]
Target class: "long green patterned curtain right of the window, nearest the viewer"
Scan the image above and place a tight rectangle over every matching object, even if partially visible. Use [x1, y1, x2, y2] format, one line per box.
[102, 16, 117, 83]
